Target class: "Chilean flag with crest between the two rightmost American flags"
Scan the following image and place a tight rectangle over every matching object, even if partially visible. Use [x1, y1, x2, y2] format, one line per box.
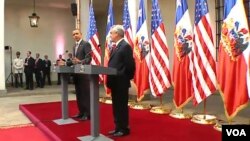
[173, 0, 193, 109]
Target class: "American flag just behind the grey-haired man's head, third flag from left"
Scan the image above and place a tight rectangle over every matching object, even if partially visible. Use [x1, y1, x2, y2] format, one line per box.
[123, 0, 134, 48]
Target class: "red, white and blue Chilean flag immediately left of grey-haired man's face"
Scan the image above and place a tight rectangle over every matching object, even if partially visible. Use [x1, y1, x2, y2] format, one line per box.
[104, 0, 114, 96]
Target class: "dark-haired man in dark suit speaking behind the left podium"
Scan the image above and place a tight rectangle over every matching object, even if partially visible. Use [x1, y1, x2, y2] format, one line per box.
[66, 29, 92, 120]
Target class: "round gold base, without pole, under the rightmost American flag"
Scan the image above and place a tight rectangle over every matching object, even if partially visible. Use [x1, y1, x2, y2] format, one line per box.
[191, 114, 216, 124]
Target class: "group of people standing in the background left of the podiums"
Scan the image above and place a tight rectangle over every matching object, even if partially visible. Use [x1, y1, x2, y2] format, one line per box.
[13, 51, 73, 90]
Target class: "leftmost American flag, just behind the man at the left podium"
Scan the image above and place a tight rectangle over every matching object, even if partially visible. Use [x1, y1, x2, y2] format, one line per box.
[87, 3, 103, 82]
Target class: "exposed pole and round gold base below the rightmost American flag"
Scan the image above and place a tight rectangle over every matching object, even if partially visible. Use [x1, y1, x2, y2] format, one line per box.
[191, 99, 216, 124]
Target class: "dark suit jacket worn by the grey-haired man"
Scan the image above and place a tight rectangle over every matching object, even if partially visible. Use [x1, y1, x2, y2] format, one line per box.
[107, 40, 135, 88]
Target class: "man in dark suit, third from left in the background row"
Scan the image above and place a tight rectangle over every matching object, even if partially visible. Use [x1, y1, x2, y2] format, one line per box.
[34, 53, 43, 88]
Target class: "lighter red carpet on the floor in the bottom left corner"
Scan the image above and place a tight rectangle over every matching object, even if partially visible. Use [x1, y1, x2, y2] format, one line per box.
[0, 125, 49, 141]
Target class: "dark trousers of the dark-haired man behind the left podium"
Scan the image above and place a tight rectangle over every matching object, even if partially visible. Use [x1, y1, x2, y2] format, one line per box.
[74, 74, 90, 116]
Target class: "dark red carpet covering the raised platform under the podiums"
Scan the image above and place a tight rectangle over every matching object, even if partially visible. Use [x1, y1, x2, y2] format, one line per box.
[20, 101, 221, 141]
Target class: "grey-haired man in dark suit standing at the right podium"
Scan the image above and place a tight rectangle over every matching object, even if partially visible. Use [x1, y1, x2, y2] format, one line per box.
[107, 25, 135, 137]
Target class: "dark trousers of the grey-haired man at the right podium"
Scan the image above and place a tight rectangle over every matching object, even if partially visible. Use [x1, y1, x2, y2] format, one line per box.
[111, 85, 129, 132]
